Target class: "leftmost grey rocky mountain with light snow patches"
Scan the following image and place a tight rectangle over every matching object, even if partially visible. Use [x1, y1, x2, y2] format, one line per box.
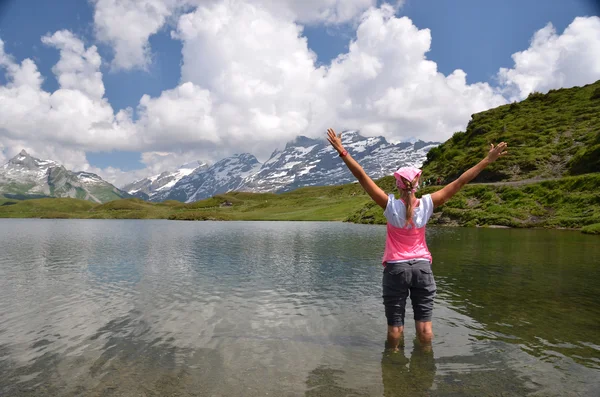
[0, 150, 130, 203]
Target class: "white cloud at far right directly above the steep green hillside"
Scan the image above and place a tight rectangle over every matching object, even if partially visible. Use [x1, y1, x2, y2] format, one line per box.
[498, 17, 600, 100]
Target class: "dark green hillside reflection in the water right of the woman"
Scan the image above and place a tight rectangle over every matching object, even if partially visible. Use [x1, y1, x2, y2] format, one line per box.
[429, 228, 600, 369]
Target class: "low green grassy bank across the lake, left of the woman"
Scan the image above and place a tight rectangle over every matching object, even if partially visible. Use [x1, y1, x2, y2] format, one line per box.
[0, 184, 369, 221]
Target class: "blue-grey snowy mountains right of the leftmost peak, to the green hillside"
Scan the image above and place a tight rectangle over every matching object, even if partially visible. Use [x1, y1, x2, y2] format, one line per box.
[124, 131, 439, 202]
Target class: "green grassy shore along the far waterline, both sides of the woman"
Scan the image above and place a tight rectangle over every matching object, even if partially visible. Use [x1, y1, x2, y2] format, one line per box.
[0, 173, 600, 234]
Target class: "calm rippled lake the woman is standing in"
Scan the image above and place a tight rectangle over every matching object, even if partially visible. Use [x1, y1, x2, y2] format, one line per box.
[0, 219, 600, 397]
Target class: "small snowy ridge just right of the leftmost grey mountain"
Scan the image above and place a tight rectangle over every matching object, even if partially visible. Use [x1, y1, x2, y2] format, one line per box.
[123, 161, 208, 201]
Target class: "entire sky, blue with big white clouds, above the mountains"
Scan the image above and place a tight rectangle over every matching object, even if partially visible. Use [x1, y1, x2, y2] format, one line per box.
[0, 0, 600, 186]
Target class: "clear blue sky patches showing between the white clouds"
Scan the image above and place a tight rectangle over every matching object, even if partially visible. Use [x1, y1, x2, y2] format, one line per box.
[0, 0, 599, 170]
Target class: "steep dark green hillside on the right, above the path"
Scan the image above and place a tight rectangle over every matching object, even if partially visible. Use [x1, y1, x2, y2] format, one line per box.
[423, 81, 600, 182]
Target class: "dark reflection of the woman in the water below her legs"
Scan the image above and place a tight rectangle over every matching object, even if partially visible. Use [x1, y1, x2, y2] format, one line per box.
[381, 340, 436, 397]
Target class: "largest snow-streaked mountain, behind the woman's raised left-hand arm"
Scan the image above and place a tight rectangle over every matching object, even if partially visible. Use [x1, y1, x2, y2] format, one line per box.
[238, 131, 439, 192]
